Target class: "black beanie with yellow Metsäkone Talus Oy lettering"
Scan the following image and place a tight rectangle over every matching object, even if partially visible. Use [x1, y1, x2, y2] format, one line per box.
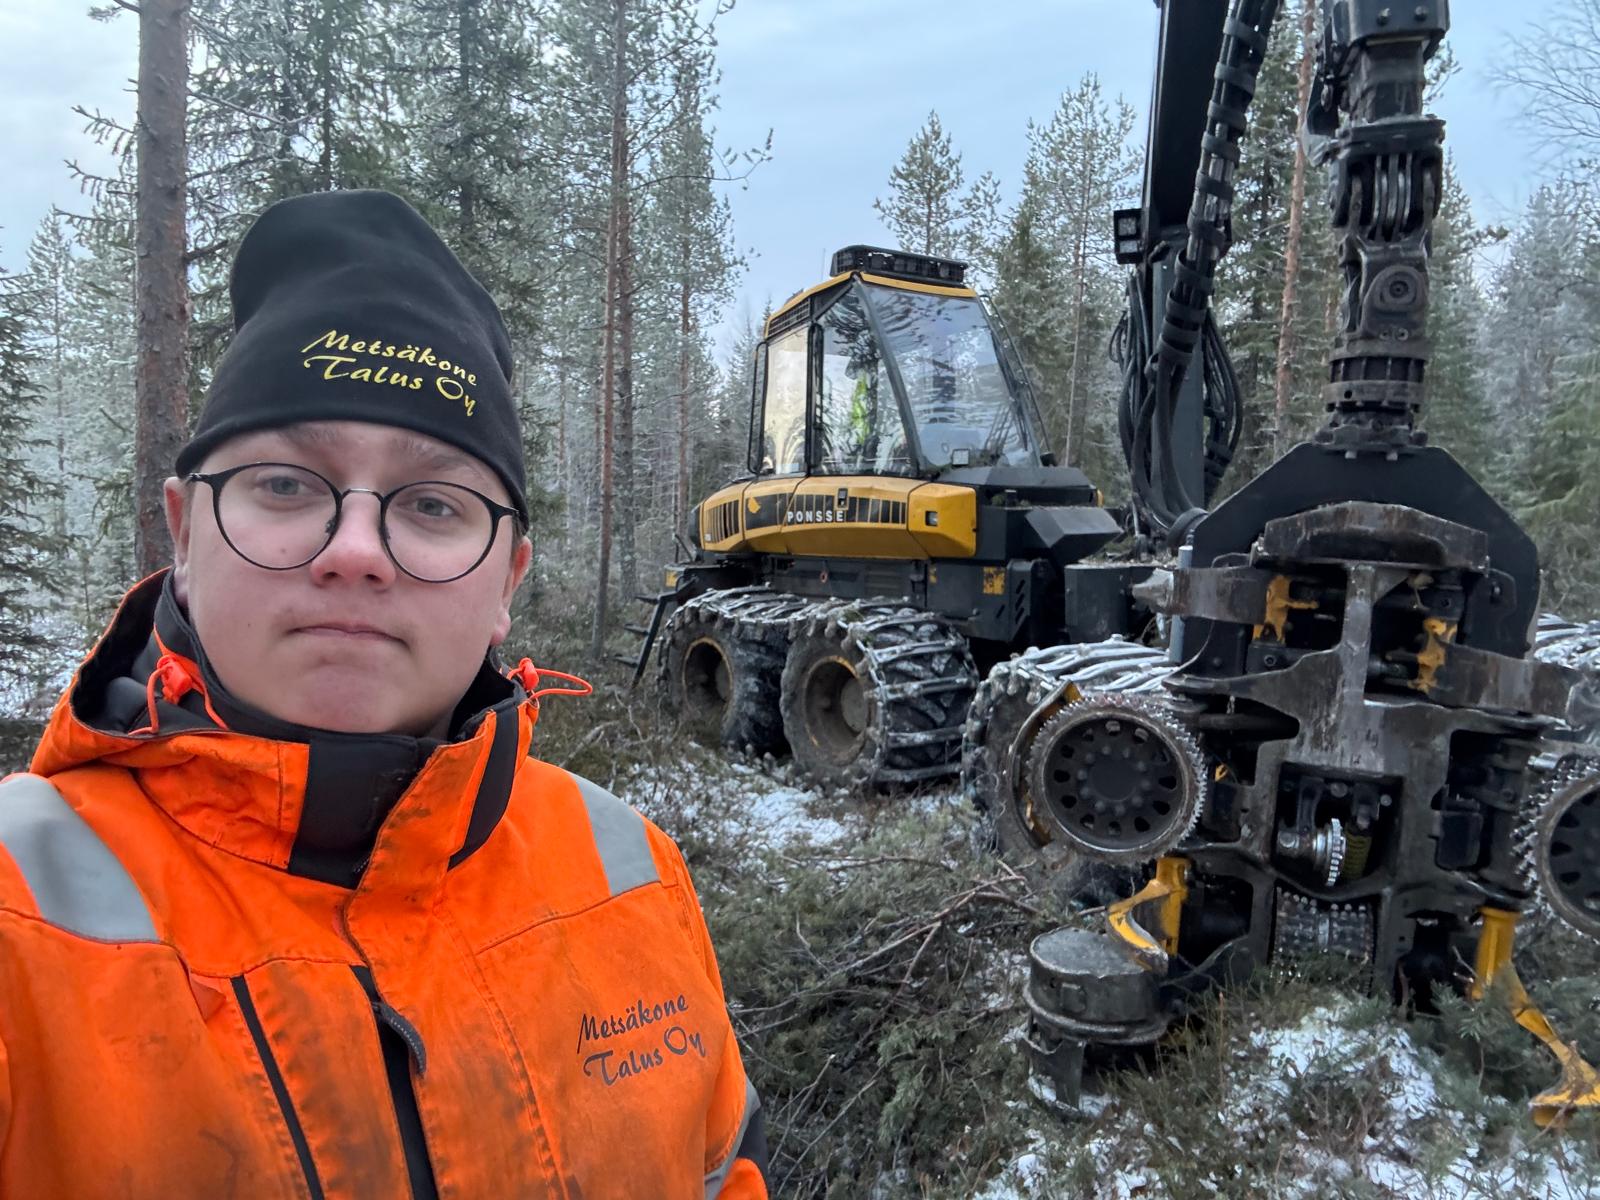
[178, 192, 528, 523]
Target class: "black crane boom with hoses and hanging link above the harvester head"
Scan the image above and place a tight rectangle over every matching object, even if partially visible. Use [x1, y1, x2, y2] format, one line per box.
[1115, 0, 1450, 546]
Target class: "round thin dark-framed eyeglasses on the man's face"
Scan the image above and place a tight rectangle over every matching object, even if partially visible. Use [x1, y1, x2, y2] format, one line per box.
[186, 462, 522, 584]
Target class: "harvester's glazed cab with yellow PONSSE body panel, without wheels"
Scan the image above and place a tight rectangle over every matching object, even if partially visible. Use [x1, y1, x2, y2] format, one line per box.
[690, 246, 1120, 579]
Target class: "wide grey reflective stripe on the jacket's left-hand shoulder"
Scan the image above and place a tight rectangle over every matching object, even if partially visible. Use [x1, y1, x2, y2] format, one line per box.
[0, 774, 157, 942]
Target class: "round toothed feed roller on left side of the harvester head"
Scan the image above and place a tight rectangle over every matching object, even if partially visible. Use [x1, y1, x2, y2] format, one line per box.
[1027, 693, 1206, 864]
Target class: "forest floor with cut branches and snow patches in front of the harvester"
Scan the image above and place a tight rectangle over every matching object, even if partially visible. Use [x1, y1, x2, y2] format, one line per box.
[534, 643, 1600, 1200]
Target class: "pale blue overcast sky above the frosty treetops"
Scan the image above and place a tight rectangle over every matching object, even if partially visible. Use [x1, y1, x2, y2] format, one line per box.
[0, 0, 1562, 356]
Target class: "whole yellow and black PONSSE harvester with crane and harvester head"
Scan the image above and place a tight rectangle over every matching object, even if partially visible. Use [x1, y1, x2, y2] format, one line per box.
[637, 0, 1600, 1120]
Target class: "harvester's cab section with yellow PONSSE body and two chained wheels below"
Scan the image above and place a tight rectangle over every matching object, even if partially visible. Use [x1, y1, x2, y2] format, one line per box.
[635, 246, 1154, 786]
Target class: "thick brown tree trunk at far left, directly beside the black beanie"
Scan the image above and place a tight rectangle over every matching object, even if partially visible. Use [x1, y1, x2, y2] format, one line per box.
[133, 0, 189, 576]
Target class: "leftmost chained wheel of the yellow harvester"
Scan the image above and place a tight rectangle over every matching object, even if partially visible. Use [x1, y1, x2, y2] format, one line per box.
[661, 610, 784, 754]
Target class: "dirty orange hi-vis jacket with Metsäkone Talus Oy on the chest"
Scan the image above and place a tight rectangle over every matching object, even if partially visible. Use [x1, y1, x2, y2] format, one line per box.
[0, 576, 766, 1200]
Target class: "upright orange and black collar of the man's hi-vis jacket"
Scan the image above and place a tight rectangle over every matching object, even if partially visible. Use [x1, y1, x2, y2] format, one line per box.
[30, 571, 538, 888]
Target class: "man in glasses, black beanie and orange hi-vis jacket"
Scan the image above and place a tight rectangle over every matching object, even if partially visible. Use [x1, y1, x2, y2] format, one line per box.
[0, 192, 766, 1200]
